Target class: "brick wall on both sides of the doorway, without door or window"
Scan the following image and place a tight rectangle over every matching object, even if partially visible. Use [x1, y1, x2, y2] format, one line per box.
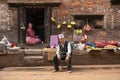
[0, 0, 120, 42]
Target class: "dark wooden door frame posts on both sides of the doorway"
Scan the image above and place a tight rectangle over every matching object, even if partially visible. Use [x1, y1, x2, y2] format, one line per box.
[18, 6, 51, 44]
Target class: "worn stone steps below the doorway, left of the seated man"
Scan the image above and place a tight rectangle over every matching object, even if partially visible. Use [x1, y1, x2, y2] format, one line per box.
[21, 49, 44, 65]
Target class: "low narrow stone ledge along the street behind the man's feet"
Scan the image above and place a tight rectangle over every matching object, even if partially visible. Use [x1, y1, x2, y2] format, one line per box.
[1, 64, 120, 71]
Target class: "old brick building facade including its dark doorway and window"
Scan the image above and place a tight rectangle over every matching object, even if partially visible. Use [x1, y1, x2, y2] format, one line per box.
[0, 0, 120, 43]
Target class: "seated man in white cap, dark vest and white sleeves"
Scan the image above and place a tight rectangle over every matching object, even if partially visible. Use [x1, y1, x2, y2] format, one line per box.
[53, 34, 72, 73]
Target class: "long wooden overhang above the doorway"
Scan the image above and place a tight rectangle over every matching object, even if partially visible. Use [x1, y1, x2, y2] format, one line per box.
[7, 0, 61, 6]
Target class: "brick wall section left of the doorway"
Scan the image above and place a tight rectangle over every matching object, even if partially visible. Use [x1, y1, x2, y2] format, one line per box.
[0, 3, 18, 42]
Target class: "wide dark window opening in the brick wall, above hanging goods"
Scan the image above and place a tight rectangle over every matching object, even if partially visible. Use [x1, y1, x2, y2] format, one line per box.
[74, 15, 104, 29]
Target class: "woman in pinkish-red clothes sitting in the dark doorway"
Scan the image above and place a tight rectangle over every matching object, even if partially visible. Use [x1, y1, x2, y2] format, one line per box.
[26, 23, 41, 44]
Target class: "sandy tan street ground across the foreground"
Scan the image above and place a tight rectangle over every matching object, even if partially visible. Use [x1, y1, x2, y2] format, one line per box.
[0, 66, 120, 80]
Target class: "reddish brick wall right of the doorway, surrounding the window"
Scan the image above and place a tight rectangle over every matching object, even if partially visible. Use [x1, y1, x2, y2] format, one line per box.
[52, 0, 120, 41]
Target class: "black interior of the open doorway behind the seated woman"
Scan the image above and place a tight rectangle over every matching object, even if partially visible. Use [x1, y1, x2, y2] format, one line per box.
[26, 7, 45, 41]
